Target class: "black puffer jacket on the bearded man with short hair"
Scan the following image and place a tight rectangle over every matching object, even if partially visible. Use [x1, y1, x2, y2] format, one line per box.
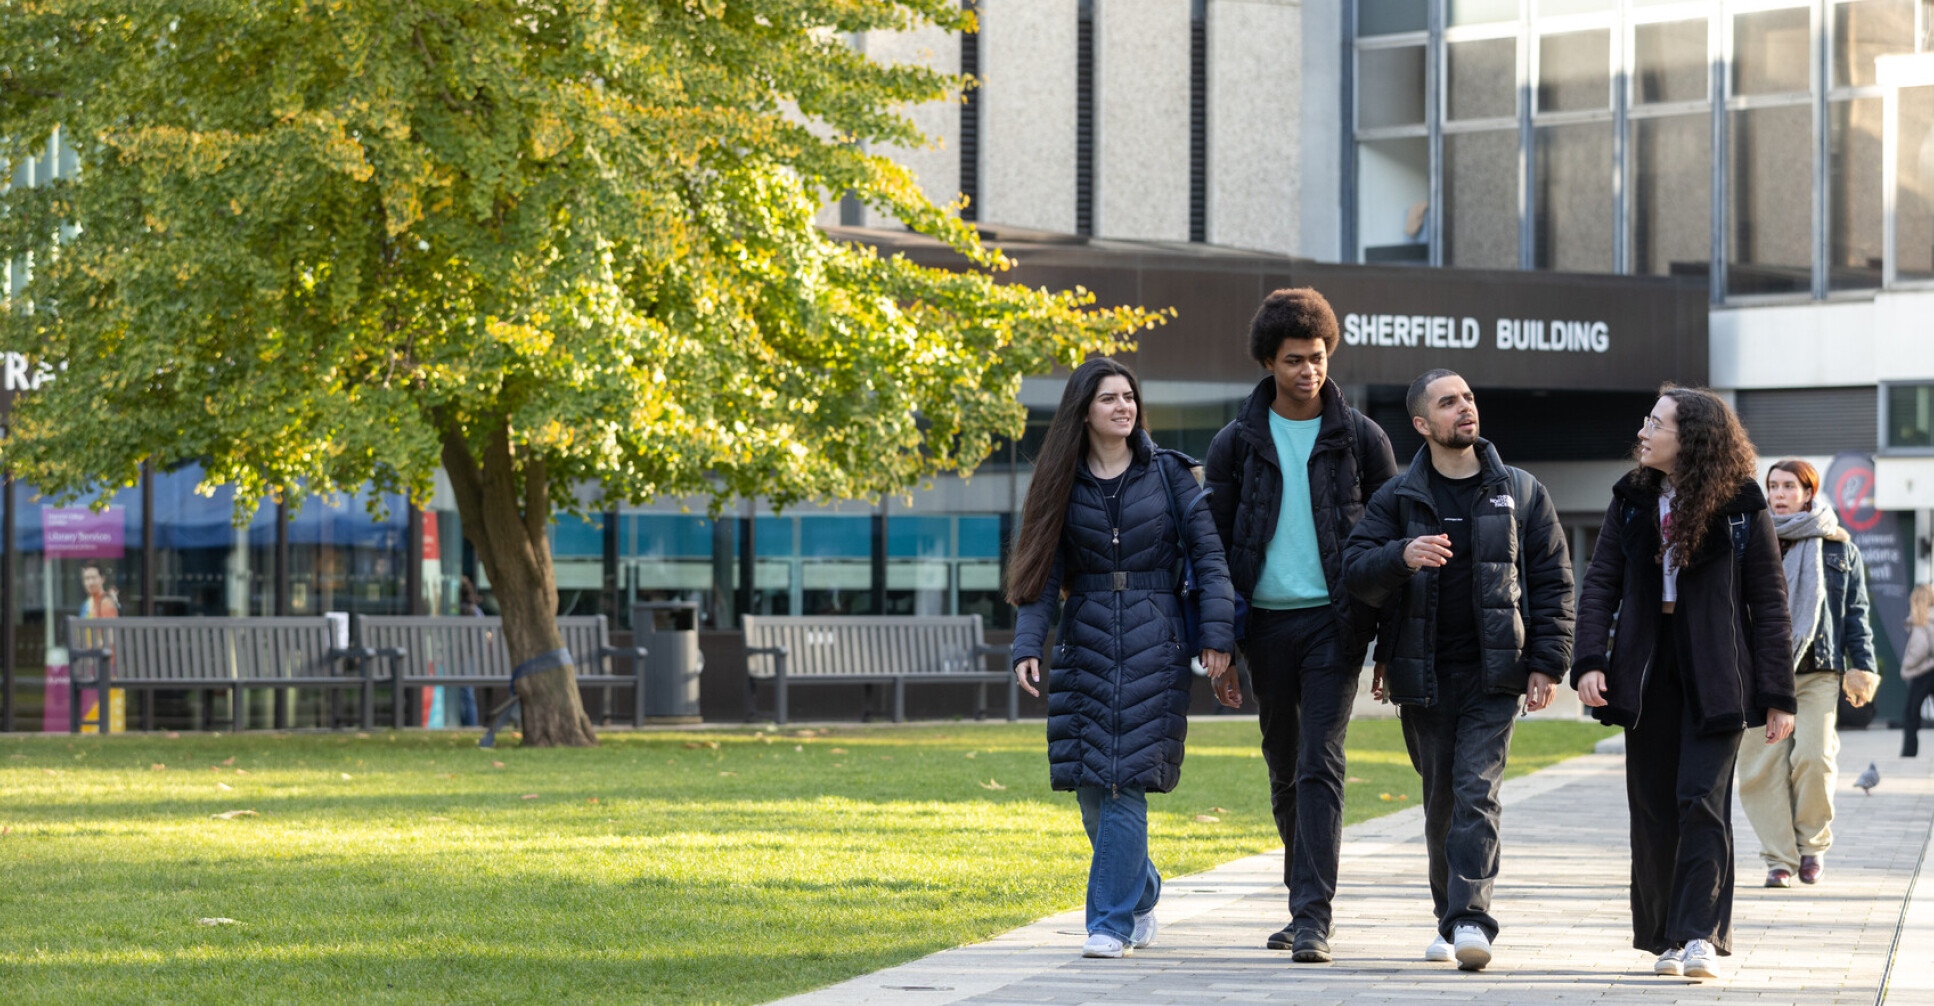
[1344, 439, 1572, 706]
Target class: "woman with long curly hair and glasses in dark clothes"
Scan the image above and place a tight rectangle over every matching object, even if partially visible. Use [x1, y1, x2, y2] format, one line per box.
[1572, 385, 1795, 979]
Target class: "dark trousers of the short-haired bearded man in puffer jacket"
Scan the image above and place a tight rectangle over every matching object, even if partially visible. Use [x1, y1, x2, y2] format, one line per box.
[1398, 658, 1524, 940]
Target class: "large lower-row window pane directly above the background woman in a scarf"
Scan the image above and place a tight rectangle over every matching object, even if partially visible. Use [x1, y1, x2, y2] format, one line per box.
[1727, 104, 1812, 294]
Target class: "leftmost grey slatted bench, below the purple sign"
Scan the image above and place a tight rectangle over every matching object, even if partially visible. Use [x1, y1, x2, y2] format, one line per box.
[68, 615, 375, 733]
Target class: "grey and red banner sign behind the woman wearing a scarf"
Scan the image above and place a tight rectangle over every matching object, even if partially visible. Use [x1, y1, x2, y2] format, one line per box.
[1820, 451, 1915, 710]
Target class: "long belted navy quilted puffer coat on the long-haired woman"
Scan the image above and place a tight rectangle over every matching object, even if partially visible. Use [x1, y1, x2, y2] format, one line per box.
[1013, 431, 1236, 793]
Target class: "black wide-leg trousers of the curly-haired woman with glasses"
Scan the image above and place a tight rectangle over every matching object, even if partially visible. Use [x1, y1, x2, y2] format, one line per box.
[1625, 615, 1744, 954]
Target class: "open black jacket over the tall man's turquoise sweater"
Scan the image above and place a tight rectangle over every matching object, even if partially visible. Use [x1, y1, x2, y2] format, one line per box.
[1207, 377, 1396, 653]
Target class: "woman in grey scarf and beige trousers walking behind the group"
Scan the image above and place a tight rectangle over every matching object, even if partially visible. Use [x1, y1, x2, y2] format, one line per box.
[1739, 459, 1880, 888]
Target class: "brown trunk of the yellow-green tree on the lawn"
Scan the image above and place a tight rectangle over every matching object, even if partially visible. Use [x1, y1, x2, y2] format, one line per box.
[443, 420, 598, 747]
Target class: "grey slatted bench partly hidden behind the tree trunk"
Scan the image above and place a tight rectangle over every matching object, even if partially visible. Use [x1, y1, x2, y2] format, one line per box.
[356, 615, 644, 731]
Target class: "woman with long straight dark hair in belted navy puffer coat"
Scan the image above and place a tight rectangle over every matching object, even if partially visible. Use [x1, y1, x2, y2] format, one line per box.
[1008, 358, 1236, 958]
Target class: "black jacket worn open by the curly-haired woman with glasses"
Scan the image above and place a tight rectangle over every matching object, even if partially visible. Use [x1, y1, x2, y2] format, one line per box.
[1570, 474, 1797, 733]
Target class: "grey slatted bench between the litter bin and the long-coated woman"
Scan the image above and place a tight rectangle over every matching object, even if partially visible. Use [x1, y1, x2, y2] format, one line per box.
[741, 615, 1021, 724]
